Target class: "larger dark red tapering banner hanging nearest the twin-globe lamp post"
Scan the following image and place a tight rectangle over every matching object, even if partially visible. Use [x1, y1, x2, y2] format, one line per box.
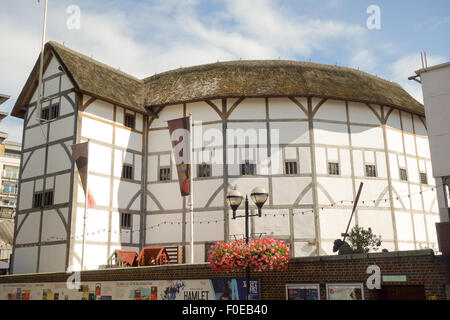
[167, 117, 192, 197]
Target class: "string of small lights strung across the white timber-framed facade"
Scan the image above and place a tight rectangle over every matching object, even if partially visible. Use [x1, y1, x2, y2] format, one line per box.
[29, 182, 437, 241]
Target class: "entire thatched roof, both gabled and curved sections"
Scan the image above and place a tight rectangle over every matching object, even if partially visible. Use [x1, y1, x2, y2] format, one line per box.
[11, 41, 424, 118]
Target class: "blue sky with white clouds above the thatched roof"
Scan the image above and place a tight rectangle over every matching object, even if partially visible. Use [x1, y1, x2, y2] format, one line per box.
[0, 0, 450, 142]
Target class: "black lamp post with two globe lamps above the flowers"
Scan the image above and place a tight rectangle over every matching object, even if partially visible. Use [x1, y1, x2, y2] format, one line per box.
[226, 187, 269, 300]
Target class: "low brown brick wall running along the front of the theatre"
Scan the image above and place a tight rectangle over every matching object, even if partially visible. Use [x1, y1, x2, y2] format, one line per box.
[0, 250, 450, 300]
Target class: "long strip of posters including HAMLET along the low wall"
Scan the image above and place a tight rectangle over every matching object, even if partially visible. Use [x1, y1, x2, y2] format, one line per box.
[0, 279, 261, 300]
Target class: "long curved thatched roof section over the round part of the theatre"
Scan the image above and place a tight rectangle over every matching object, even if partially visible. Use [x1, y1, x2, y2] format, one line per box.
[144, 60, 424, 114]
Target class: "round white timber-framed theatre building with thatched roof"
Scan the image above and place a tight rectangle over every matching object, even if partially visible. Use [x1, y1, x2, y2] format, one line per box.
[12, 42, 439, 273]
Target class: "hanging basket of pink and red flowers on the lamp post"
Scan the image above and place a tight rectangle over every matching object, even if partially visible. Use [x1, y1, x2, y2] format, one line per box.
[209, 238, 289, 271]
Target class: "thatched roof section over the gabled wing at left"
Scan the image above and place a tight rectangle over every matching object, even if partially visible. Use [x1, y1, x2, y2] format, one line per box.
[11, 41, 145, 118]
